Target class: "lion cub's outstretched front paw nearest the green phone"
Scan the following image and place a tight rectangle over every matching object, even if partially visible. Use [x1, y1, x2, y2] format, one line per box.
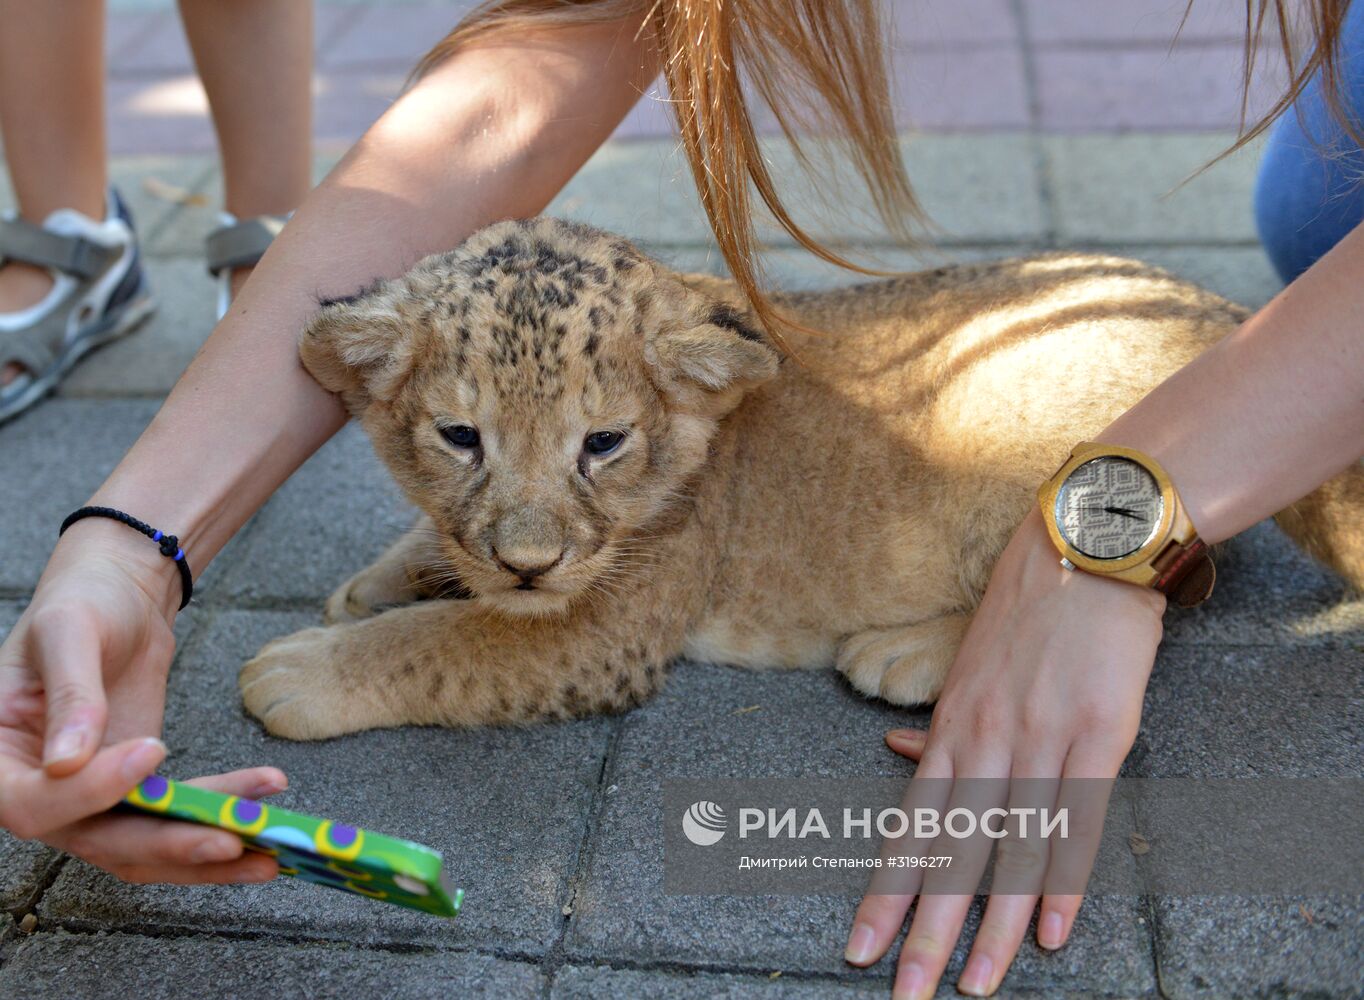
[237, 628, 368, 739]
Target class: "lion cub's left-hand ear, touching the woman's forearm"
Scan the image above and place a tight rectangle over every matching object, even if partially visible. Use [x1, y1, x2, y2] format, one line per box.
[299, 284, 423, 413]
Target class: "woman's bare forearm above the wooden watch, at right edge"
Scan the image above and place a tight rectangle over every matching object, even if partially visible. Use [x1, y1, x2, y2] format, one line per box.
[1099, 226, 1364, 542]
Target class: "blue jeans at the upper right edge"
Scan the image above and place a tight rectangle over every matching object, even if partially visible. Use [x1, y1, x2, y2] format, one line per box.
[1255, 0, 1364, 282]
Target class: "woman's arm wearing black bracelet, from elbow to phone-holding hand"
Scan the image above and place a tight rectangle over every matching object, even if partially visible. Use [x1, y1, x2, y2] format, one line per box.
[0, 20, 657, 881]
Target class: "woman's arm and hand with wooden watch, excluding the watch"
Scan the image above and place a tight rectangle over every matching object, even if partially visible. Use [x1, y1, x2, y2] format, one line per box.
[847, 226, 1364, 1000]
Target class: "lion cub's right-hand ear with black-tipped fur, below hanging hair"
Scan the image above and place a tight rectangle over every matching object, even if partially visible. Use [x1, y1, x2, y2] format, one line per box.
[649, 303, 780, 412]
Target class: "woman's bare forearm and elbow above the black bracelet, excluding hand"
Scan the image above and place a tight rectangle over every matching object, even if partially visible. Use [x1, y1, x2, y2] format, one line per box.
[81, 23, 656, 608]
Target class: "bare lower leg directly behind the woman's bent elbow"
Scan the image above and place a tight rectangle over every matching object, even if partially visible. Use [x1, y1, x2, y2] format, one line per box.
[180, 0, 312, 295]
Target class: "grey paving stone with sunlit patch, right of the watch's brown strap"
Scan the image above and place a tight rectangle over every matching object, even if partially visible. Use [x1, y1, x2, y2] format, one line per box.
[1165, 521, 1364, 656]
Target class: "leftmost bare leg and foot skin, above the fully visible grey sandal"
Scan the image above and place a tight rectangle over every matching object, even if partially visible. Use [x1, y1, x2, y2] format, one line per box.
[0, 0, 108, 385]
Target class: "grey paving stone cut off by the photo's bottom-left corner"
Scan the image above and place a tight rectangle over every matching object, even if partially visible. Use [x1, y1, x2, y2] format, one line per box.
[0, 933, 543, 1000]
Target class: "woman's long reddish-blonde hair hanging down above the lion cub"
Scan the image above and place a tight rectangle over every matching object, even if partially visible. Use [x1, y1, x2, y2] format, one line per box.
[413, 0, 1359, 344]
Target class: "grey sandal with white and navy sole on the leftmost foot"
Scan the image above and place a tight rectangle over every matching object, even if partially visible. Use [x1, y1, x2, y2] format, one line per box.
[0, 191, 155, 423]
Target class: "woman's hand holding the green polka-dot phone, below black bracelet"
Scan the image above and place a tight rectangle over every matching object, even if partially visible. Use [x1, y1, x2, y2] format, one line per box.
[0, 521, 286, 883]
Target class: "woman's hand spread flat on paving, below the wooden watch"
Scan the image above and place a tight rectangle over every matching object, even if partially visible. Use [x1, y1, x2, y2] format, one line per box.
[847, 512, 1165, 1000]
